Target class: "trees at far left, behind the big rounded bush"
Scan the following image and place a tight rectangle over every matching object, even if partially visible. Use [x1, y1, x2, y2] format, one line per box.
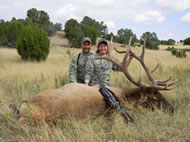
[0, 8, 62, 48]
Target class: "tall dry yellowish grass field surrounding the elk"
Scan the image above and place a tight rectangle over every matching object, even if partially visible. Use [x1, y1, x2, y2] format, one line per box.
[0, 39, 190, 142]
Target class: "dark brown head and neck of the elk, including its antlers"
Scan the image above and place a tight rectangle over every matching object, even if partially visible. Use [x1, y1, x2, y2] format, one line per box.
[97, 36, 177, 112]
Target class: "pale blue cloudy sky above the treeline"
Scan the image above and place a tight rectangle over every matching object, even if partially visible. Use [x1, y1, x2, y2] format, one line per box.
[0, 0, 190, 41]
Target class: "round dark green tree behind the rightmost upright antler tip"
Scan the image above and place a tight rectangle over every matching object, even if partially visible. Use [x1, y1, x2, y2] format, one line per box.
[141, 32, 160, 50]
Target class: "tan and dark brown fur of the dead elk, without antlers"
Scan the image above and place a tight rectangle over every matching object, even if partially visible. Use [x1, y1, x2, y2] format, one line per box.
[19, 83, 173, 123]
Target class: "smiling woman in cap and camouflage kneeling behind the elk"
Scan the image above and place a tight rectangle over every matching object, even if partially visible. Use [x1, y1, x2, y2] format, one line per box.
[84, 39, 121, 86]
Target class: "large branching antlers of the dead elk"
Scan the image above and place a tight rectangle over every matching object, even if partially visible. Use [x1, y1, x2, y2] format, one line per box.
[96, 35, 177, 90]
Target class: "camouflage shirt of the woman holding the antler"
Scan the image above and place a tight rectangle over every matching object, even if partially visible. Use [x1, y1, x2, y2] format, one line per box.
[85, 54, 121, 86]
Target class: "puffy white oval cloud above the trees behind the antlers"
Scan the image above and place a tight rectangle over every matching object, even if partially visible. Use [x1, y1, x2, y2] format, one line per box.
[134, 11, 165, 25]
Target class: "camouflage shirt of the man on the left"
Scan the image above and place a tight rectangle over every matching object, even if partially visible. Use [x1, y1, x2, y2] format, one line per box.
[69, 53, 92, 83]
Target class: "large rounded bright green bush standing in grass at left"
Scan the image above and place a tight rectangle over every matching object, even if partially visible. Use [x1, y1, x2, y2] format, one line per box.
[16, 25, 50, 61]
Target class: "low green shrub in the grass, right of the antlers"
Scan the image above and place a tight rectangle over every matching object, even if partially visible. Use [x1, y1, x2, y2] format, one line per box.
[167, 47, 187, 58]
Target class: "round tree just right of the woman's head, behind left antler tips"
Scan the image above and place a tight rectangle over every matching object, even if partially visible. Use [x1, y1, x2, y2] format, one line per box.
[116, 29, 137, 45]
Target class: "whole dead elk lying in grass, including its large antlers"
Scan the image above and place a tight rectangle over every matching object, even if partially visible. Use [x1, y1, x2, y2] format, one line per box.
[15, 35, 176, 123]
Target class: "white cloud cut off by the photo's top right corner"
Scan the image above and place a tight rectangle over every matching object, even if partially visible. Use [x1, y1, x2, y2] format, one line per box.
[156, 0, 190, 11]
